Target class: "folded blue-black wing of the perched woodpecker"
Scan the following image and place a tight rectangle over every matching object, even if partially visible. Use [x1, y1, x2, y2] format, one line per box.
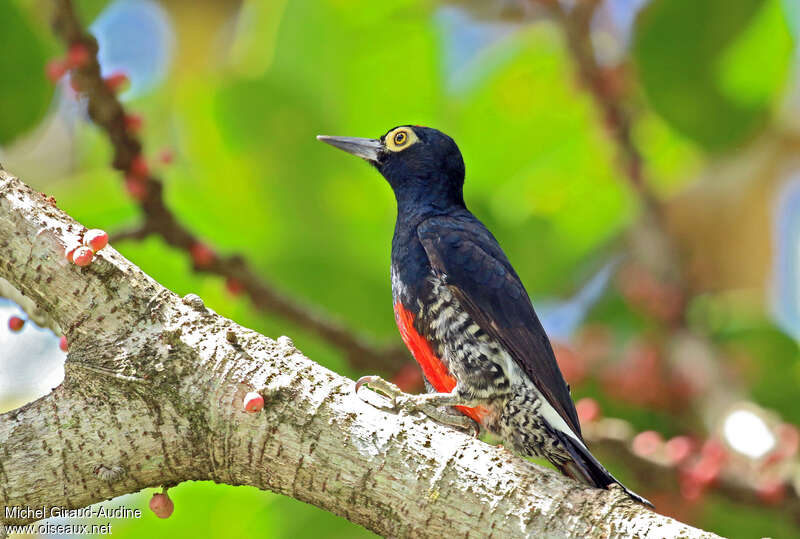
[417, 215, 581, 437]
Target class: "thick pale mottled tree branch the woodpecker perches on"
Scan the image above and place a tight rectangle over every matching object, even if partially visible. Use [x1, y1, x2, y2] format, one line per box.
[0, 171, 716, 538]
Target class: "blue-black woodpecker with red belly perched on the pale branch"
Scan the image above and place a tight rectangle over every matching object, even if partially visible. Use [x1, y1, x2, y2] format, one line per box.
[317, 125, 652, 506]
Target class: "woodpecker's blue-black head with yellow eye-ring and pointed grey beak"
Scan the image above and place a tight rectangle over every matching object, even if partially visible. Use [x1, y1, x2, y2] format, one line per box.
[317, 125, 464, 208]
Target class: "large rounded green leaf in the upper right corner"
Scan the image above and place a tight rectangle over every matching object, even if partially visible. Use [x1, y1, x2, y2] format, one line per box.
[633, 0, 792, 151]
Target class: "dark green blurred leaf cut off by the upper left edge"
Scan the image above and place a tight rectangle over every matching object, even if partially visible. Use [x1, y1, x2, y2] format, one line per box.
[0, 2, 53, 144]
